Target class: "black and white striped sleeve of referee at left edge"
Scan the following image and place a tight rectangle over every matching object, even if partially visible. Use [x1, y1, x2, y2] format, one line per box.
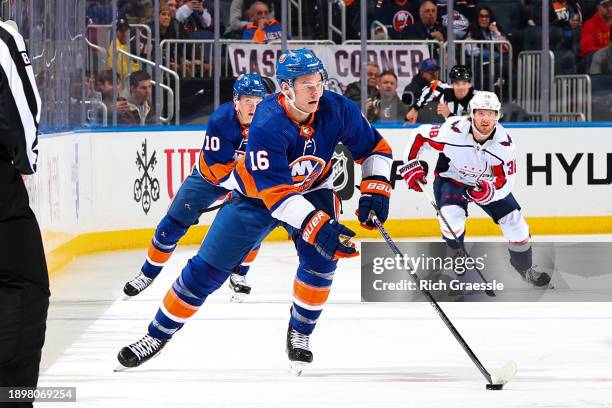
[0, 22, 41, 174]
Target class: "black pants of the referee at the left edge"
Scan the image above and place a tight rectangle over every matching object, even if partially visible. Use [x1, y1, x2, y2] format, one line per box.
[0, 216, 49, 408]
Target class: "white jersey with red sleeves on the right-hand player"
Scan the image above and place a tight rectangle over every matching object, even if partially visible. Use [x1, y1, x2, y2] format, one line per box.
[403, 116, 516, 201]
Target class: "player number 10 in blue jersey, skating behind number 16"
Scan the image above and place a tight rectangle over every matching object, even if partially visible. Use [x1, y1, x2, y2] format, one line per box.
[123, 74, 266, 301]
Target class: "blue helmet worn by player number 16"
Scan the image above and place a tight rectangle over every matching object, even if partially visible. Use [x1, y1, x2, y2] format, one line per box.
[276, 48, 327, 86]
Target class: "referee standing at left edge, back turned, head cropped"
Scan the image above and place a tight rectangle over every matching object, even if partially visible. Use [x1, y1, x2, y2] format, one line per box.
[0, 22, 49, 408]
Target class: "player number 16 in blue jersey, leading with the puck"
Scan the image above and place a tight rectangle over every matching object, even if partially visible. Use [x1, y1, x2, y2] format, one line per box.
[118, 49, 392, 374]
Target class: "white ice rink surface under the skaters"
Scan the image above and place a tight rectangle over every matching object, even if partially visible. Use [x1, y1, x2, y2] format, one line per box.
[39, 236, 612, 408]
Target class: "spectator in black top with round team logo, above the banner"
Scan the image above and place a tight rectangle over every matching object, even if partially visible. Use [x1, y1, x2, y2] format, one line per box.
[374, 0, 419, 40]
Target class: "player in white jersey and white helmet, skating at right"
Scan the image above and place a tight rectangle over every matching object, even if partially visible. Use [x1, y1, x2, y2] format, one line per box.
[399, 92, 550, 287]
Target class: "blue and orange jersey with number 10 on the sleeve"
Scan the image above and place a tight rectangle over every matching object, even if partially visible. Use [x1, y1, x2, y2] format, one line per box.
[197, 101, 249, 185]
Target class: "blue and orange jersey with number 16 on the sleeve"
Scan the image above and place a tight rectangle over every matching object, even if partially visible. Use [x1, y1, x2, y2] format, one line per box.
[232, 91, 392, 228]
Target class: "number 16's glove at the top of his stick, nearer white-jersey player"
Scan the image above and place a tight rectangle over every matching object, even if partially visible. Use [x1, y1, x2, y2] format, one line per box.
[357, 176, 391, 229]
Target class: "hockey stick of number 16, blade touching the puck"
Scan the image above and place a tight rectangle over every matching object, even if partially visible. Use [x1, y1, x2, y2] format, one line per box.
[370, 211, 517, 390]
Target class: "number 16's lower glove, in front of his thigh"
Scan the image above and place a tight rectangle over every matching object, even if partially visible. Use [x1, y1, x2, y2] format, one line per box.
[302, 210, 359, 261]
